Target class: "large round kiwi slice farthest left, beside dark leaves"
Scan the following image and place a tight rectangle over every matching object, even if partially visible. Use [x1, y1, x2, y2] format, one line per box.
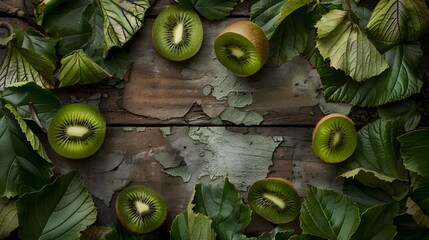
[47, 103, 106, 159]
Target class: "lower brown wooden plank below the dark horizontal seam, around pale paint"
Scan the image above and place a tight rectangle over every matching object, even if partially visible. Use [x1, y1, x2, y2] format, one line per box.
[40, 126, 340, 234]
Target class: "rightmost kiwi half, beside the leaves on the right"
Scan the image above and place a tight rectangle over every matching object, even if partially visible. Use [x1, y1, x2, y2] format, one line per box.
[312, 113, 357, 163]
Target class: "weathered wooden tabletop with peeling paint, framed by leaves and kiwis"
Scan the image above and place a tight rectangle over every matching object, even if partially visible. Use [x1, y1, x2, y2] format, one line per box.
[3, 0, 350, 234]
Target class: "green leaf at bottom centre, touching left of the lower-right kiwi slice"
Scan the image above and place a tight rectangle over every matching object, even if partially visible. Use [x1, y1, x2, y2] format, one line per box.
[191, 178, 252, 240]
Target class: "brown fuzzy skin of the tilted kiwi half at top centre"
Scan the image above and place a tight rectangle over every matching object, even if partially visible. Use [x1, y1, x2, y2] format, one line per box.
[218, 20, 270, 70]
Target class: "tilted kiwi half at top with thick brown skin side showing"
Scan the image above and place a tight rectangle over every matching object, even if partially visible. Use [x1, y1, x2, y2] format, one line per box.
[214, 20, 269, 77]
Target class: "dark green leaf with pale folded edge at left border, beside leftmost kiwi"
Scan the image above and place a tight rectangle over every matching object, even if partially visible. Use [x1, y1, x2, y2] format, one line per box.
[0, 104, 53, 197]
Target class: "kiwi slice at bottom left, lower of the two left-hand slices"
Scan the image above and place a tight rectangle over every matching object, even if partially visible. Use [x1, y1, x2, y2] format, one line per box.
[115, 185, 167, 234]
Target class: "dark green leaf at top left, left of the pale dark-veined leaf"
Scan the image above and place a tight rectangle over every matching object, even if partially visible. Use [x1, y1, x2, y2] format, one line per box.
[40, 0, 93, 56]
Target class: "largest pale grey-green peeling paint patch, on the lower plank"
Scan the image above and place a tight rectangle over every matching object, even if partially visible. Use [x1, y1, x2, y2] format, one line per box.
[155, 127, 281, 191]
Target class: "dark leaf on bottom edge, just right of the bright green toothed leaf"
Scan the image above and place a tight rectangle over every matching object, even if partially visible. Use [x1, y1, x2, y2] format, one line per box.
[352, 202, 399, 240]
